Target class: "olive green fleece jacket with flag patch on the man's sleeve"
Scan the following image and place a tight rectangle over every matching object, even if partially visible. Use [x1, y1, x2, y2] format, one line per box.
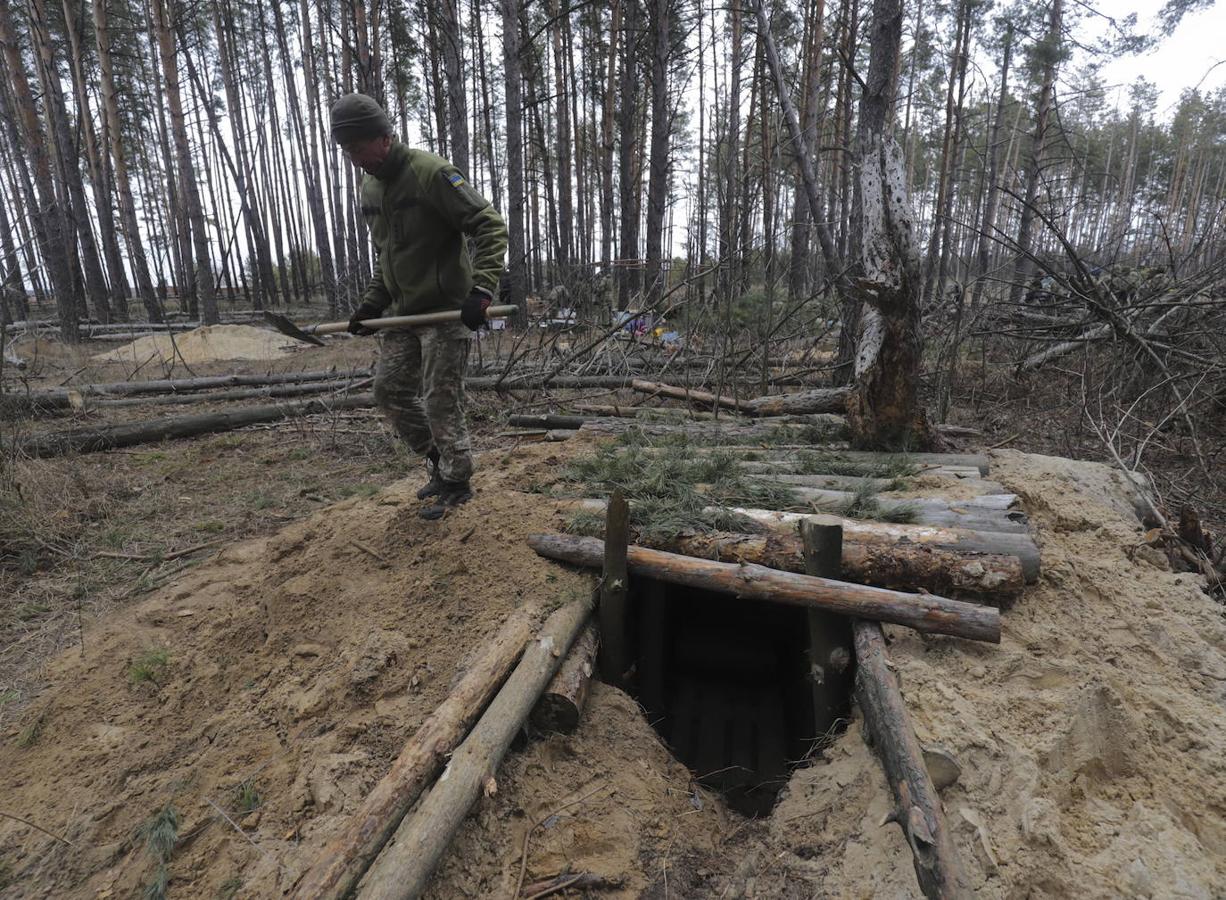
[362, 141, 506, 315]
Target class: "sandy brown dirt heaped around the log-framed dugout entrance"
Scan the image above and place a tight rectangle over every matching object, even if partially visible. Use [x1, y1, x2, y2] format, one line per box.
[0, 328, 1226, 899]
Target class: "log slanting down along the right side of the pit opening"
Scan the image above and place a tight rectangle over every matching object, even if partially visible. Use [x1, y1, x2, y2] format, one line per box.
[852, 622, 973, 900]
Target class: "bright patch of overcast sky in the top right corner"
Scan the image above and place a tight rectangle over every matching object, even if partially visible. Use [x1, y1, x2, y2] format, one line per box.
[1095, 0, 1226, 119]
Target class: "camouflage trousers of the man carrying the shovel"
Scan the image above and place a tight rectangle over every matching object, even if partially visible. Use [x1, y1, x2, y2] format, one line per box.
[375, 322, 472, 481]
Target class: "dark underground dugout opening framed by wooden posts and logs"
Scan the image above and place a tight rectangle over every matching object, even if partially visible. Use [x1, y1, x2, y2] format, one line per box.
[624, 578, 855, 815]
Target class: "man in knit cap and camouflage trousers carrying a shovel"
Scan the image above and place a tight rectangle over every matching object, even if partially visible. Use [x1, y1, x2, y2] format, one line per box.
[331, 93, 506, 519]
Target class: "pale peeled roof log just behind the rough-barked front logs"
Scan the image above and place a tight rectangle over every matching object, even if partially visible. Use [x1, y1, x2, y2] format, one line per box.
[712, 506, 1040, 584]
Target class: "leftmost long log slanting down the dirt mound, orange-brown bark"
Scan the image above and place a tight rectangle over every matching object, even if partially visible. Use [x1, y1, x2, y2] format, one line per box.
[294, 608, 536, 900]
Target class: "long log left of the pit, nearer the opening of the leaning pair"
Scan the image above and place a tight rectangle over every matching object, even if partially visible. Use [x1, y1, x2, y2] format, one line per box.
[358, 598, 592, 900]
